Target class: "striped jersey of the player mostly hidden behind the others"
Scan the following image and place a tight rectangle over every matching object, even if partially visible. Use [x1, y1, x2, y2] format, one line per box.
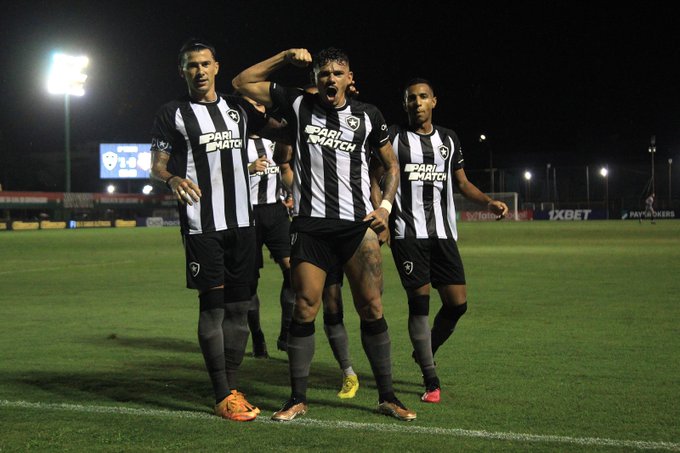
[248, 137, 282, 206]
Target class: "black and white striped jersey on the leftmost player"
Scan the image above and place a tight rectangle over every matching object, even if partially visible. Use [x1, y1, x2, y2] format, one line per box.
[151, 94, 266, 234]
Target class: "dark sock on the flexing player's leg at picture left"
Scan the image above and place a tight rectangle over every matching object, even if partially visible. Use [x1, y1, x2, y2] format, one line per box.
[288, 319, 314, 401]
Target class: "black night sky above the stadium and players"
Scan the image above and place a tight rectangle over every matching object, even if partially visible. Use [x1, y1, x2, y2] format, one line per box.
[0, 0, 680, 190]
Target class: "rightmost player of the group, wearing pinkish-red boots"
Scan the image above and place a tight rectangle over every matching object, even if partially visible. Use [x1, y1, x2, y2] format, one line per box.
[382, 79, 508, 403]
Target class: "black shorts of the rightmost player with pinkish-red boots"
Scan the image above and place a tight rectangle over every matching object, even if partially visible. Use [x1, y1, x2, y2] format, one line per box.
[391, 238, 465, 289]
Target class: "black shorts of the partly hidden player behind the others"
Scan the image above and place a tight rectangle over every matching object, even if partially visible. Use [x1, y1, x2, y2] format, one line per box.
[253, 203, 290, 269]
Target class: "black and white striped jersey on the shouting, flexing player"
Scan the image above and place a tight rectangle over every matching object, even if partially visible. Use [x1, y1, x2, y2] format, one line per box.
[271, 83, 388, 221]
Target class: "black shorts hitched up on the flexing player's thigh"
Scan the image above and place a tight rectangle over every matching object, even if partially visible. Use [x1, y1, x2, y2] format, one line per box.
[290, 217, 370, 274]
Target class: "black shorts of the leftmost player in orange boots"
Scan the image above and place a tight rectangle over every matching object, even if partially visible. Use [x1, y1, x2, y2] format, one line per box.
[183, 227, 255, 293]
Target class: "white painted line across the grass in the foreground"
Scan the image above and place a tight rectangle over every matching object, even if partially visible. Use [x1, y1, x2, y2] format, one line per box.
[0, 400, 680, 451]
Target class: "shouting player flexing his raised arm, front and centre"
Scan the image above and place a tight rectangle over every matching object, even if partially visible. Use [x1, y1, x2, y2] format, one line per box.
[232, 48, 416, 421]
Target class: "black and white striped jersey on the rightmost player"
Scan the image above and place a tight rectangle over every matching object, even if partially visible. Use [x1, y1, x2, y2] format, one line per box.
[389, 126, 463, 240]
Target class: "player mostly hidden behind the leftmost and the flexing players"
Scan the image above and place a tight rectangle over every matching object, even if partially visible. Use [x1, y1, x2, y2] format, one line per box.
[245, 97, 295, 357]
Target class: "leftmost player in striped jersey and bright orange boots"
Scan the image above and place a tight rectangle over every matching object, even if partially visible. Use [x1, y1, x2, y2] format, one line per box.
[151, 39, 284, 421]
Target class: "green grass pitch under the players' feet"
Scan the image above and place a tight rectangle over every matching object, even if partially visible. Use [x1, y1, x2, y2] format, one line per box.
[0, 220, 680, 453]
